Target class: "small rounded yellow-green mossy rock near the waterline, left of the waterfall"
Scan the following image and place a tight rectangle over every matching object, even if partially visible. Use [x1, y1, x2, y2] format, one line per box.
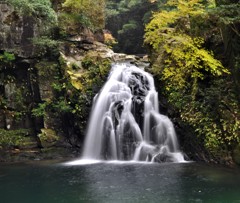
[38, 128, 59, 148]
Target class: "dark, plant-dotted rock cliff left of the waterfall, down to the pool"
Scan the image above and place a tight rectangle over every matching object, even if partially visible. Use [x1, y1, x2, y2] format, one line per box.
[0, 2, 113, 162]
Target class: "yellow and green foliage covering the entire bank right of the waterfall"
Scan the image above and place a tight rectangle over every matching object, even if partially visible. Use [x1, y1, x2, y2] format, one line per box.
[145, 0, 240, 156]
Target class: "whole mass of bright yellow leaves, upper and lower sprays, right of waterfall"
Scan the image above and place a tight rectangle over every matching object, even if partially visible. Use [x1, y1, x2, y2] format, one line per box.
[145, 1, 228, 93]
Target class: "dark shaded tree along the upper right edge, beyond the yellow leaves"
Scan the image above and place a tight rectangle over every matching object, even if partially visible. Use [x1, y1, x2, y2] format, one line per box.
[210, 0, 240, 102]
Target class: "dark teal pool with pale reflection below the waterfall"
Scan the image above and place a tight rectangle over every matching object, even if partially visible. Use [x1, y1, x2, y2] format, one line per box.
[0, 163, 240, 203]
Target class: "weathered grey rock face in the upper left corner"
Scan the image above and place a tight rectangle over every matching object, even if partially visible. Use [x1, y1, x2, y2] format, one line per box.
[0, 3, 39, 57]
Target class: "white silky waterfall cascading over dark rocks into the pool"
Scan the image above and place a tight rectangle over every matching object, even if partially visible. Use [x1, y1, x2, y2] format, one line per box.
[83, 63, 184, 162]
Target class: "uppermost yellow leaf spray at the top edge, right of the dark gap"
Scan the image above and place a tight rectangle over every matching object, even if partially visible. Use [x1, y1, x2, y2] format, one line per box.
[145, 0, 208, 50]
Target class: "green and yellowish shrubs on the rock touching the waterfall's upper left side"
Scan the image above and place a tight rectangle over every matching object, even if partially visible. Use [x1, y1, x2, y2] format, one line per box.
[54, 52, 111, 123]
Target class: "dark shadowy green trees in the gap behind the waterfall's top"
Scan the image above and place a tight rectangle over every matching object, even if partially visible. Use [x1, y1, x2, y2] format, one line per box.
[106, 0, 161, 54]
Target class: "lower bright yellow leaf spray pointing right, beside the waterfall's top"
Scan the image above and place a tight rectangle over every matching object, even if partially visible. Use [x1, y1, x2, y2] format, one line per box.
[151, 30, 227, 88]
